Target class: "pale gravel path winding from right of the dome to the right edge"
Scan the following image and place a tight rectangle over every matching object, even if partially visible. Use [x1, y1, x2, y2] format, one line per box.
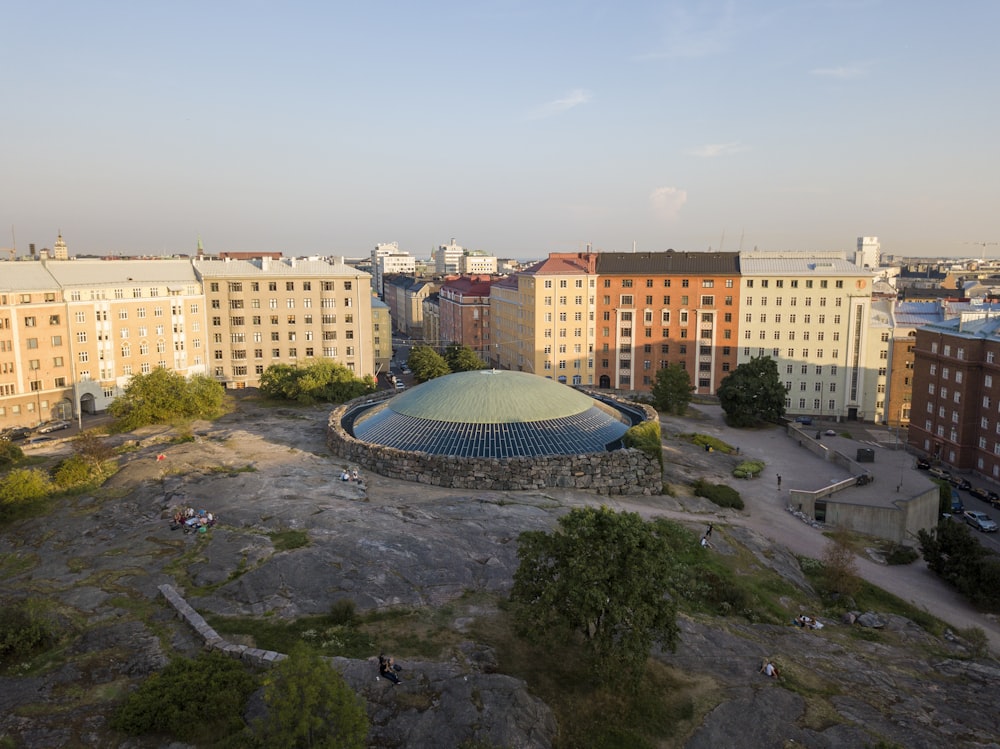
[616, 406, 1000, 653]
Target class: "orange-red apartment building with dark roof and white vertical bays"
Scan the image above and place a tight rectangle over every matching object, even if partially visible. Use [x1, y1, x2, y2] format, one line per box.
[595, 250, 740, 394]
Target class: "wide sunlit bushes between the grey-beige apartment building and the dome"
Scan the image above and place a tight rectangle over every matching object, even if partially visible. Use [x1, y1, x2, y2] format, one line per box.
[260, 359, 375, 405]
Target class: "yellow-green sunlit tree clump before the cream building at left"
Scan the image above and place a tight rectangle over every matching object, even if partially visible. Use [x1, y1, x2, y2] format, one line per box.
[108, 367, 225, 431]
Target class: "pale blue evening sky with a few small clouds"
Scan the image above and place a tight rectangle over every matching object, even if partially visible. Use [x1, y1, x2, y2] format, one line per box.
[0, 0, 1000, 259]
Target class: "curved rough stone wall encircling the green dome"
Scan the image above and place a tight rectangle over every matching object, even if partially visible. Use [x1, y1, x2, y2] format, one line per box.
[326, 398, 663, 495]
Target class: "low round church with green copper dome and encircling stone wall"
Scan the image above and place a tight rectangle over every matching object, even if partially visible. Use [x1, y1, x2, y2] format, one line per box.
[328, 370, 662, 494]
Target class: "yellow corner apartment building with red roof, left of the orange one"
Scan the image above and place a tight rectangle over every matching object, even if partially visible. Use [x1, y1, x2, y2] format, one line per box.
[490, 252, 597, 385]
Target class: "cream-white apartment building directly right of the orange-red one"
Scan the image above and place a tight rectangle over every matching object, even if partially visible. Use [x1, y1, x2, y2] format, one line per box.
[737, 252, 875, 420]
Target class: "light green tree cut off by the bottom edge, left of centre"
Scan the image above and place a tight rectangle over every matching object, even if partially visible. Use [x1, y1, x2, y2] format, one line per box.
[256, 644, 368, 749]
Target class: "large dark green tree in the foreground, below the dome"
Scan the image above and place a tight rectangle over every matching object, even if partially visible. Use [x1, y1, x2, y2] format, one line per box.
[510, 507, 678, 685]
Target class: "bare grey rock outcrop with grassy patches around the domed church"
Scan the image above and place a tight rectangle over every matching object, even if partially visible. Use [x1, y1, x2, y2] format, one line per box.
[0, 394, 1000, 749]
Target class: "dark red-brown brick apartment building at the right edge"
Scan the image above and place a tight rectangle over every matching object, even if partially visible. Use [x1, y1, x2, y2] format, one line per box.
[907, 312, 1000, 480]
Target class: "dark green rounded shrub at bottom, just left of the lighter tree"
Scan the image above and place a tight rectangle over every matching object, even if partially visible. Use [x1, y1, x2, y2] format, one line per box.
[111, 652, 257, 744]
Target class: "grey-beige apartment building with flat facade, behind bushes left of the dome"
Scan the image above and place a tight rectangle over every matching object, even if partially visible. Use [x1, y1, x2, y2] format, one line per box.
[194, 258, 381, 388]
